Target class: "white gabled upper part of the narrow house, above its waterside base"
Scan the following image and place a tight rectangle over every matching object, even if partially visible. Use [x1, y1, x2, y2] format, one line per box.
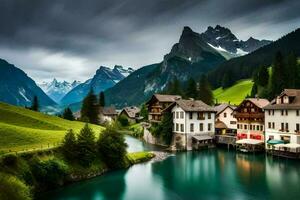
[214, 103, 237, 134]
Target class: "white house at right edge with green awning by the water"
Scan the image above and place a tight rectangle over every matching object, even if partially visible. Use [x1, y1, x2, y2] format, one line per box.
[264, 89, 300, 158]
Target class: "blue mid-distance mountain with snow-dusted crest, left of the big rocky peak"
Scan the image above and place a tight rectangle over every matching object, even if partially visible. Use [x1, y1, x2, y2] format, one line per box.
[60, 65, 134, 105]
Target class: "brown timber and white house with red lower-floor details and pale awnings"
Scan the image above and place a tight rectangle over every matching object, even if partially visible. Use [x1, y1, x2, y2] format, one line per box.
[234, 98, 270, 151]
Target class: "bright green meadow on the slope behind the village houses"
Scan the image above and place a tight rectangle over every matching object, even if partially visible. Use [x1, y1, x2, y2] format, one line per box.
[213, 79, 253, 105]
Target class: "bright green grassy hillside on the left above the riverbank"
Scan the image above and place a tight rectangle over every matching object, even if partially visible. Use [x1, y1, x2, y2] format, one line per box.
[0, 102, 102, 154]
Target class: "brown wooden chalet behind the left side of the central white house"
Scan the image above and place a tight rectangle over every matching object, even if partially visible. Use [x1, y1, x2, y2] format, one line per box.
[146, 94, 181, 123]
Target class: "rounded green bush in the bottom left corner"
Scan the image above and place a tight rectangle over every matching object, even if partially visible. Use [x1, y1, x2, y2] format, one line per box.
[0, 173, 32, 200]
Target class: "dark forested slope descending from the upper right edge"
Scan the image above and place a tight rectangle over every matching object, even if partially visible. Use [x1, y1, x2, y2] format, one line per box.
[209, 28, 300, 88]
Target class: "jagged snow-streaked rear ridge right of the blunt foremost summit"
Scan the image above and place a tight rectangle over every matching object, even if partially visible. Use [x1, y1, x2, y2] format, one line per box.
[201, 25, 272, 57]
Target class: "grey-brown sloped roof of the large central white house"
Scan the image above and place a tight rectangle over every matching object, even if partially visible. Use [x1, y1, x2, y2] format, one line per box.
[171, 99, 216, 112]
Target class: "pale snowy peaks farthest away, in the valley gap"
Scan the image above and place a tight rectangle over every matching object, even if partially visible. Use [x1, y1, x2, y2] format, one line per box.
[39, 78, 80, 103]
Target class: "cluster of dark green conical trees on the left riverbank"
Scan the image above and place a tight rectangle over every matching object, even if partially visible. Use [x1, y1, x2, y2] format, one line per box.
[61, 124, 127, 168]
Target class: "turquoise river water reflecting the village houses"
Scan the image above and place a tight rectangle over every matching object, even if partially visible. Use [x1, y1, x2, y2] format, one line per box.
[42, 137, 300, 200]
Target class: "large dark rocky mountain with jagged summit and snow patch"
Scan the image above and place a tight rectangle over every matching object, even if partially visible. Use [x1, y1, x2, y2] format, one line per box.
[102, 25, 271, 107]
